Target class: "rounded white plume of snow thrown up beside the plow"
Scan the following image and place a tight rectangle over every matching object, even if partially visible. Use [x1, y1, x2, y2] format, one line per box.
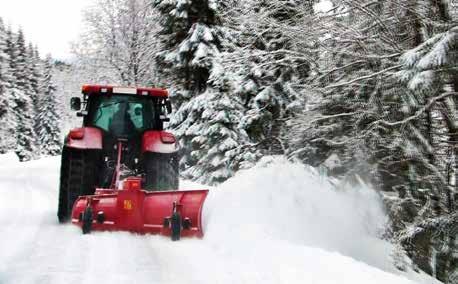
[204, 158, 392, 270]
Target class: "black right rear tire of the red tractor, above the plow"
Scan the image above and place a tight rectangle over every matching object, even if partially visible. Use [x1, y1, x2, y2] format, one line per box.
[144, 152, 179, 191]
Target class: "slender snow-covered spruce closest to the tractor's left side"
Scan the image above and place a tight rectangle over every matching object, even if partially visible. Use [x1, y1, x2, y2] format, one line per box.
[38, 55, 61, 155]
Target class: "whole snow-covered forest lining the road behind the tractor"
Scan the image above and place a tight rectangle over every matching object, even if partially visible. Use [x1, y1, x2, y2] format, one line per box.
[0, 0, 458, 283]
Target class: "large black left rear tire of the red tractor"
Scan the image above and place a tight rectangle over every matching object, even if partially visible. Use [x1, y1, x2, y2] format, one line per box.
[57, 147, 100, 223]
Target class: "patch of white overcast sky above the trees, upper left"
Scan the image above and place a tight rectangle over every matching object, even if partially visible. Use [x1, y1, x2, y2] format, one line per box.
[0, 0, 92, 59]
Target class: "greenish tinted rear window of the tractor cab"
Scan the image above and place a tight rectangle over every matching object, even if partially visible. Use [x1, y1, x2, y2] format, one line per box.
[86, 95, 161, 136]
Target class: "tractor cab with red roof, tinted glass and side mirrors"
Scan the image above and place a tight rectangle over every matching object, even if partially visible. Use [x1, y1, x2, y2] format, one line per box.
[71, 85, 172, 138]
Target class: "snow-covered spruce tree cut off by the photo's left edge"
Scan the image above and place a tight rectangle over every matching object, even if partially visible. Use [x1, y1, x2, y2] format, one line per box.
[0, 18, 16, 153]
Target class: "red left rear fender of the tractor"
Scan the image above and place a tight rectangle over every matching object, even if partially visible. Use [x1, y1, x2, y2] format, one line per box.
[65, 127, 103, 149]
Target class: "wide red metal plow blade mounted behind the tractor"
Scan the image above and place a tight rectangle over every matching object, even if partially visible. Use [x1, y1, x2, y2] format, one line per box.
[72, 183, 208, 240]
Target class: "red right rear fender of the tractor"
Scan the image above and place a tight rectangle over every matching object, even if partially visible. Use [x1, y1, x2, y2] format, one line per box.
[142, 130, 178, 154]
